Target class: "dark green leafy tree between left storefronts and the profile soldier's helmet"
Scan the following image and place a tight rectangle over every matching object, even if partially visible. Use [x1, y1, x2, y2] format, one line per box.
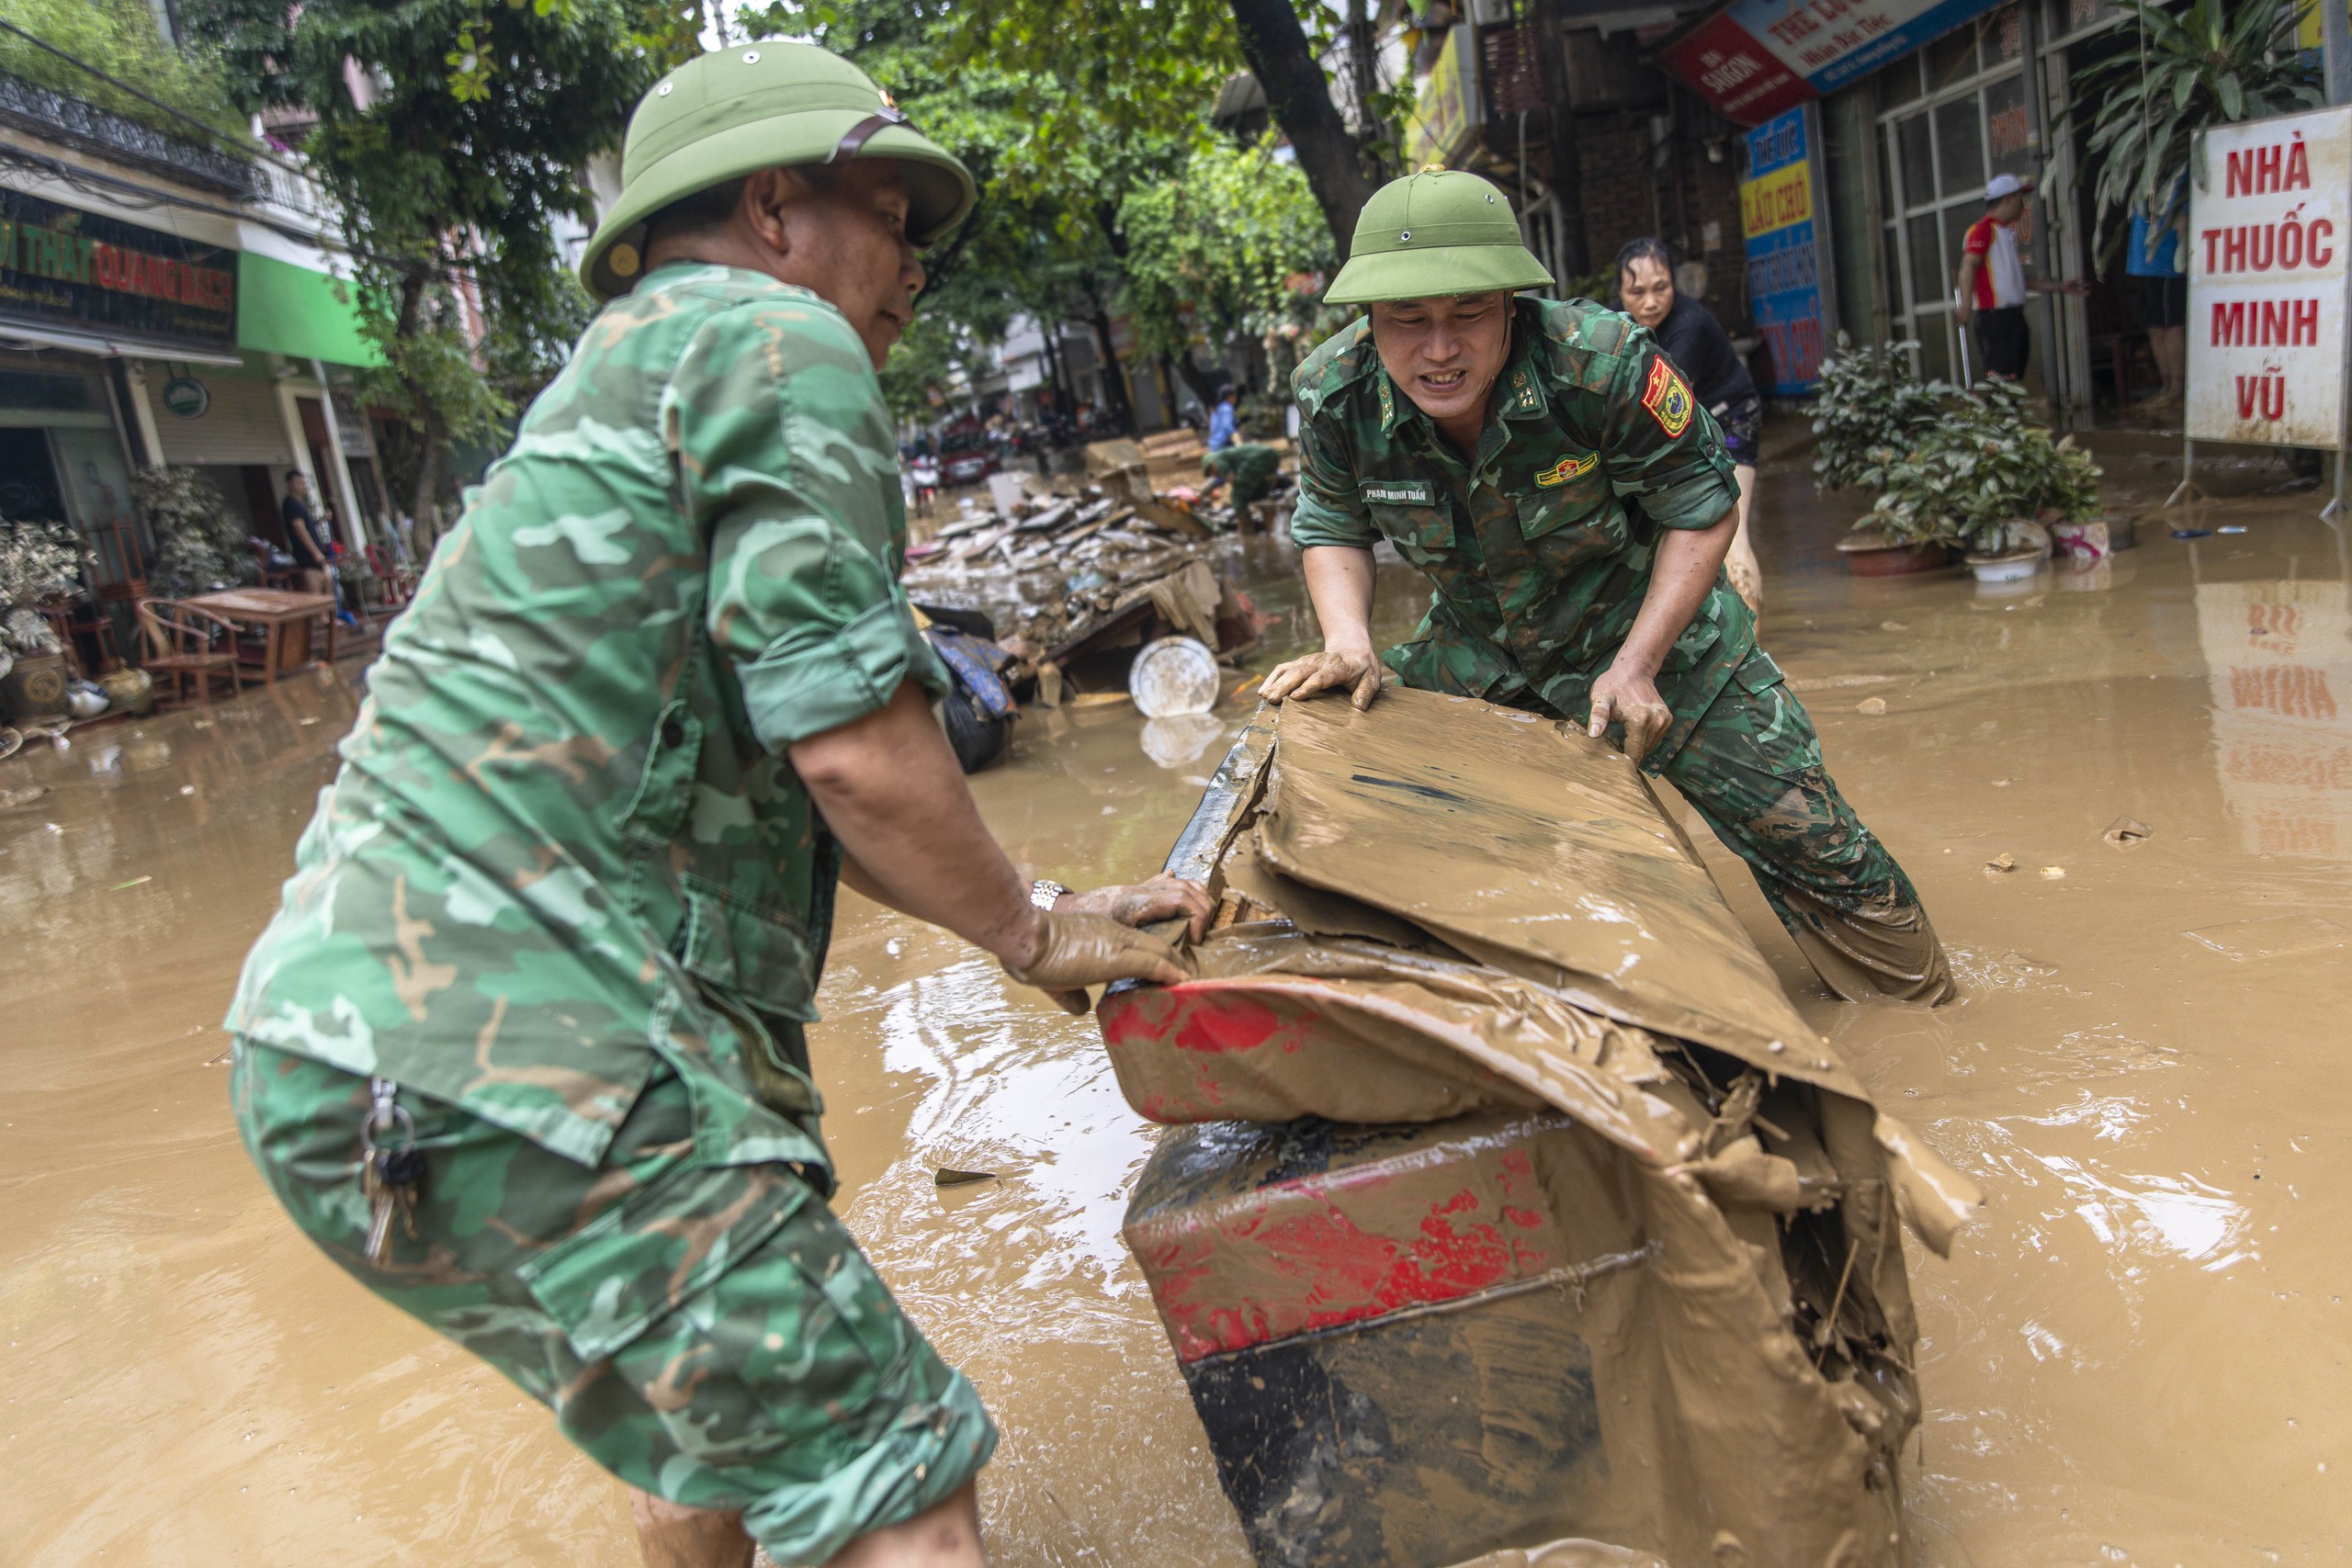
[181, 0, 675, 531]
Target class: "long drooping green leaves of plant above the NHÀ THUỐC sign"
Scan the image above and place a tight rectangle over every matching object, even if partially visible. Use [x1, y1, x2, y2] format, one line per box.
[2075, 0, 2319, 256]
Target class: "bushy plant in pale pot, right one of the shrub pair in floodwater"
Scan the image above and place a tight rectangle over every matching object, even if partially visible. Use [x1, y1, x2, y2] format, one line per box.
[1868, 381, 2100, 583]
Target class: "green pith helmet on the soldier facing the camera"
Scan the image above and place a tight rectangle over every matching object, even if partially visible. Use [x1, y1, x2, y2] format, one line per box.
[1324, 169, 1553, 306]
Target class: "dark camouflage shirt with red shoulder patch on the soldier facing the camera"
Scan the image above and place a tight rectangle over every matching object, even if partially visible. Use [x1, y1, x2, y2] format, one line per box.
[1291, 299, 1755, 771]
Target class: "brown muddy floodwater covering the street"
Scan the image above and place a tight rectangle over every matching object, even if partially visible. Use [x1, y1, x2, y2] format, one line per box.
[0, 456, 2352, 1568]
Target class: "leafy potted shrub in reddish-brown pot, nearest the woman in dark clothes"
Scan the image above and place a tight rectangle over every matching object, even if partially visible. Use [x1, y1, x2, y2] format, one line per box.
[1814, 332, 1954, 576]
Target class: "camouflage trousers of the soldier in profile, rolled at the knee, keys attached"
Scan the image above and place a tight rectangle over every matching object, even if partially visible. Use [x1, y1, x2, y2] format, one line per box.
[231, 1039, 997, 1565]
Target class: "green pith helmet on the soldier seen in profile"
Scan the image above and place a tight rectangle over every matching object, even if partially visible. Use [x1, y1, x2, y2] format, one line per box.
[581, 38, 978, 299]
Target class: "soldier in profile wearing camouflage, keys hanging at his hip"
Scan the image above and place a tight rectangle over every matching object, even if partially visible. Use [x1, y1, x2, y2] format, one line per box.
[228, 42, 1206, 1565]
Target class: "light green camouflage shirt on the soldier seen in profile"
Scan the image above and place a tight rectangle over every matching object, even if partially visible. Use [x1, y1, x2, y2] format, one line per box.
[228, 264, 945, 1173]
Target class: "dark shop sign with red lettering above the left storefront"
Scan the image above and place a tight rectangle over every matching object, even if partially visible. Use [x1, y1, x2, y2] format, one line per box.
[0, 190, 238, 348]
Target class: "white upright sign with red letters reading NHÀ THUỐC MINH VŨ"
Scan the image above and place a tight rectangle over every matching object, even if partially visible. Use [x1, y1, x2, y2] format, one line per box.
[2185, 108, 2352, 449]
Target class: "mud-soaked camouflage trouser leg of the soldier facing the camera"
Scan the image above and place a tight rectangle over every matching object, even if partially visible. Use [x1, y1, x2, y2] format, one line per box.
[1663, 653, 1954, 1001]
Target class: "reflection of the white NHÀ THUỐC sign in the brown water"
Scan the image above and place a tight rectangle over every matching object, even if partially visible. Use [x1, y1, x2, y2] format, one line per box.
[2197, 581, 2352, 861]
